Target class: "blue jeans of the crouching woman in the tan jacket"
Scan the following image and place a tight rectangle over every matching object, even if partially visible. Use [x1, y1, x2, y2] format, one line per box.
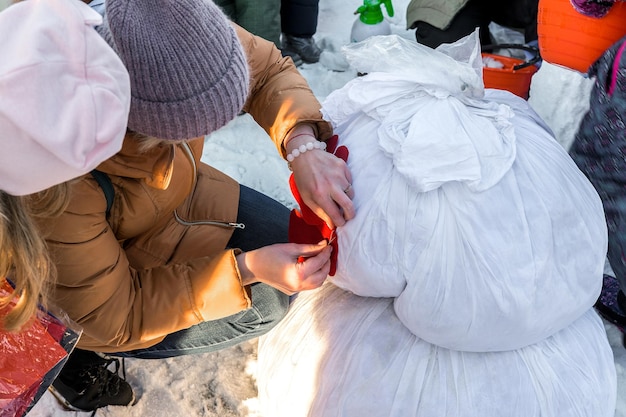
[111, 185, 289, 359]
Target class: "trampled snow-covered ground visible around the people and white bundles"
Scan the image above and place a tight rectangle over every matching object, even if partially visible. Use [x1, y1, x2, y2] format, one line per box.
[29, 0, 626, 417]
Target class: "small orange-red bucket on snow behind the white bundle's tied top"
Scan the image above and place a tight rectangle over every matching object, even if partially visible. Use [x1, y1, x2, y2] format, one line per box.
[482, 52, 537, 100]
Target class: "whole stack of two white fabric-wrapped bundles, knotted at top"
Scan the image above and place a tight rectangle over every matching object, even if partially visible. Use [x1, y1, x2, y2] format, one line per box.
[258, 34, 616, 417]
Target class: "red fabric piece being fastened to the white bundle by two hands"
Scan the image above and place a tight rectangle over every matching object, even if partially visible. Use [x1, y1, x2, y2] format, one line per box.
[289, 135, 349, 276]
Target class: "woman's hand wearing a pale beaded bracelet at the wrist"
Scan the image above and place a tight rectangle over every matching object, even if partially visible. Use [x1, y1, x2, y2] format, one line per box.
[285, 126, 355, 229]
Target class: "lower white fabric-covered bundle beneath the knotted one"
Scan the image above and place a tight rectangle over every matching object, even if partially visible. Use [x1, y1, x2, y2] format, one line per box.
[257, 283, 616, 417]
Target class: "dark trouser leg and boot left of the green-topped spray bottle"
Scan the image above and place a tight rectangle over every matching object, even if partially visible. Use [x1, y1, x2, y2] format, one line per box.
[280, 0, 322, 63]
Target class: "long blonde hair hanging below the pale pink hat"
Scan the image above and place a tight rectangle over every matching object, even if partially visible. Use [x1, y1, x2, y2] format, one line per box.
[0, 183, 69, 331]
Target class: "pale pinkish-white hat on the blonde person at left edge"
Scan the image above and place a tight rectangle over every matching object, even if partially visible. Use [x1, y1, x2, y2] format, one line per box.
[0, 0, 130, 195]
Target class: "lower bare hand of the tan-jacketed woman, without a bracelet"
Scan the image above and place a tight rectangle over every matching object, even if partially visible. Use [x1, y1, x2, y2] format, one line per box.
[236, 241, 332, 295]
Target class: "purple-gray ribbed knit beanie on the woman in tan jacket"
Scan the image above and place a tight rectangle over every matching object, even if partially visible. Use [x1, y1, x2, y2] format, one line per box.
[98, 0, 249, 140]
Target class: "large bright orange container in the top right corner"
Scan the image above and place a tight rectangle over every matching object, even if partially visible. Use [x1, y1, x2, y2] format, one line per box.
[537, 0, 626, 73]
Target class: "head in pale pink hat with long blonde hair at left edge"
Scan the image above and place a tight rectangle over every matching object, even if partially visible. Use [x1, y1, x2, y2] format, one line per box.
[0, 0, 130, 330]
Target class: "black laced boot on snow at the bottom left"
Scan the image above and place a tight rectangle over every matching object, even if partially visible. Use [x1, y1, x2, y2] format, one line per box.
[50, 349, 135, 411]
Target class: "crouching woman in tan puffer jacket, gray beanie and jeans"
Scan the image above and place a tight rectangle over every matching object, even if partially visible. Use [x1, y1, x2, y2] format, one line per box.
[41, 0, 354, 410]
